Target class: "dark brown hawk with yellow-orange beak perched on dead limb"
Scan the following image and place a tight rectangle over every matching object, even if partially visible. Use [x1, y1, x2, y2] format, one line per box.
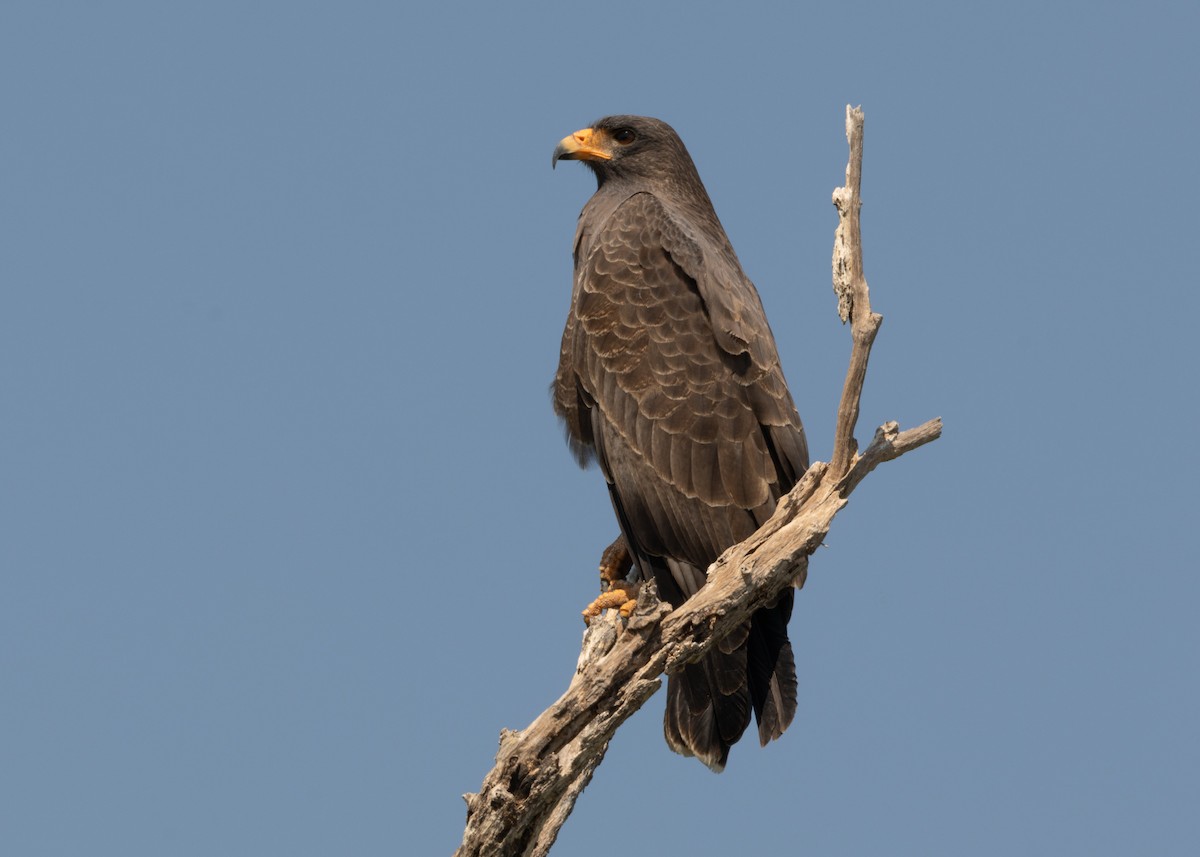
[552, 116, 809, 771]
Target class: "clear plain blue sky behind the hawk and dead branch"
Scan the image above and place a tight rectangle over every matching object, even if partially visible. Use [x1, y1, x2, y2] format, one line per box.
[0, 0, 1200, 857]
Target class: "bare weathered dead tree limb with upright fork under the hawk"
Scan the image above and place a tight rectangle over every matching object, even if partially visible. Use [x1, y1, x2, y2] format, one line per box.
[456, 107, 942, 857]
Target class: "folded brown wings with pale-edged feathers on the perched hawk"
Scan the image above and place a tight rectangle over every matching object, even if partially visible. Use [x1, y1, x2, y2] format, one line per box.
[556, 192, 808, 569]
